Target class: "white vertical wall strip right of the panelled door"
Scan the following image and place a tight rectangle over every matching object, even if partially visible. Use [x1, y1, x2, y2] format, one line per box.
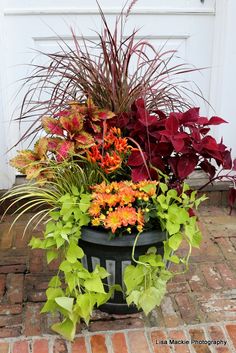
[211, 0, 236, 158]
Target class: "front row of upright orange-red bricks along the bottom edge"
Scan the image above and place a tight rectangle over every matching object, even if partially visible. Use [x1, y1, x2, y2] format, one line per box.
[0, 322, 236, 353]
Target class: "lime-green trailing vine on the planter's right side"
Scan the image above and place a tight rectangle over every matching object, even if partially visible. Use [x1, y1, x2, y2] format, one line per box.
[124, 183, 205, 315]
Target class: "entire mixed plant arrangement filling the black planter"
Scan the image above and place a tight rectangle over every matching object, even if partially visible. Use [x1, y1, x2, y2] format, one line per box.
[3, 0, 236, 340]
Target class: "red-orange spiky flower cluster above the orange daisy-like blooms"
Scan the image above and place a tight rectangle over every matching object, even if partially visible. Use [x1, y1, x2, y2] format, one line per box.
[87, 128, 131, 174]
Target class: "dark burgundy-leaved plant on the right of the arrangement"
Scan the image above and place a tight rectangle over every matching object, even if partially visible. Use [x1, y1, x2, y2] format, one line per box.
[110, 99, 236, 206]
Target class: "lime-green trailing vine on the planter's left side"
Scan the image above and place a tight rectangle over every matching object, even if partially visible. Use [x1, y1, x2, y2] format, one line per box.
[29, 185, 116, 340]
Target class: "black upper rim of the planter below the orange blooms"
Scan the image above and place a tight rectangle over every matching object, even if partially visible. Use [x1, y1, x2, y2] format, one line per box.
[81, 227, 166, 247]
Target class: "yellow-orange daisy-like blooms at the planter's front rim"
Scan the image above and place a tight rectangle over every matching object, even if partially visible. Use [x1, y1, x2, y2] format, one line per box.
[89, 181, 158, 233]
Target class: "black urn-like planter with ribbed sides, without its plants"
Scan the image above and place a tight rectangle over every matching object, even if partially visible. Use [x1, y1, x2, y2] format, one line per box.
[80, 227, 166, 314]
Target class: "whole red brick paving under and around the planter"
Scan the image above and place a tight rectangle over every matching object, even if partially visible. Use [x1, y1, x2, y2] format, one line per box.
[0, 207, 236, 353]
